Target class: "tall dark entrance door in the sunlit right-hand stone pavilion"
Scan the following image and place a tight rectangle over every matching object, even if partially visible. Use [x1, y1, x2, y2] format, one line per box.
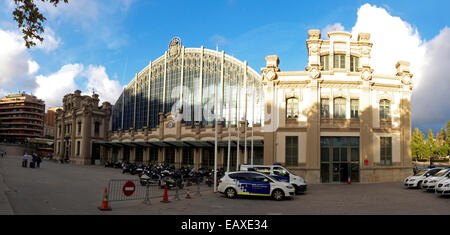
[320, 137, 360, 183]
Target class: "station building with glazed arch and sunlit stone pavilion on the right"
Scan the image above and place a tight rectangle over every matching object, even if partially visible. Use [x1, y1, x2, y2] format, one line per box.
[56, 30, 412, 183]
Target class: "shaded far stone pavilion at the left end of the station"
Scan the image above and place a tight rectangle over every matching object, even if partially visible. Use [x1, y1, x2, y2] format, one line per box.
[54, 90, 112, 165]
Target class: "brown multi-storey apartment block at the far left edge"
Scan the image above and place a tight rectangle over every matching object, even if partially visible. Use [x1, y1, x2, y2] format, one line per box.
[0, 92, 45, 143]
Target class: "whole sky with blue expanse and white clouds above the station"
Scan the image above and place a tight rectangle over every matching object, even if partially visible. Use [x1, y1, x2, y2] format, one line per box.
[0, 0, 450, 135]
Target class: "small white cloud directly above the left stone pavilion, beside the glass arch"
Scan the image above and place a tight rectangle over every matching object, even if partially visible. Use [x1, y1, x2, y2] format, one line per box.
[85, 65, 122, 104]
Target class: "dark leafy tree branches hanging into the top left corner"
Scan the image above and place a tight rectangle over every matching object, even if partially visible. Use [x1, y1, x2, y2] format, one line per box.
[13, 0, 69, 48]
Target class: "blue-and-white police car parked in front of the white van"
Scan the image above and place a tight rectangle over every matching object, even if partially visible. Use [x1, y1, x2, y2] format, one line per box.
[217, 171, 295, 201]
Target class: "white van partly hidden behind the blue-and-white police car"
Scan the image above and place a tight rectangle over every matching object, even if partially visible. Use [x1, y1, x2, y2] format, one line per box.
[240, 165, 306, 194]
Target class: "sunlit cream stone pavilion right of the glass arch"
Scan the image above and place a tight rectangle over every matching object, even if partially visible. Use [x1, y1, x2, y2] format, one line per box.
[262, 30, 412, 183]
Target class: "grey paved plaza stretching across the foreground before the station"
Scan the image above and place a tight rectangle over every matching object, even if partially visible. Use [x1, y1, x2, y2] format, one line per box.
[0, 156, 450, 215]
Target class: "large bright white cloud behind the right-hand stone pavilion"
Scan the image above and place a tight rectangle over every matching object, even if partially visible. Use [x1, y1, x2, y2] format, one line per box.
[352, 4, 450, 128]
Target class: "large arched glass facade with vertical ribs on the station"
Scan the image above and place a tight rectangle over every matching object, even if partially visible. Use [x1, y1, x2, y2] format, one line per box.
[112, 47, 264, 131]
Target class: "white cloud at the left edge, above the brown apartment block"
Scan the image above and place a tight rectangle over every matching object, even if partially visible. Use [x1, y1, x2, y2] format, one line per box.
[0, 29, 39, 86]
